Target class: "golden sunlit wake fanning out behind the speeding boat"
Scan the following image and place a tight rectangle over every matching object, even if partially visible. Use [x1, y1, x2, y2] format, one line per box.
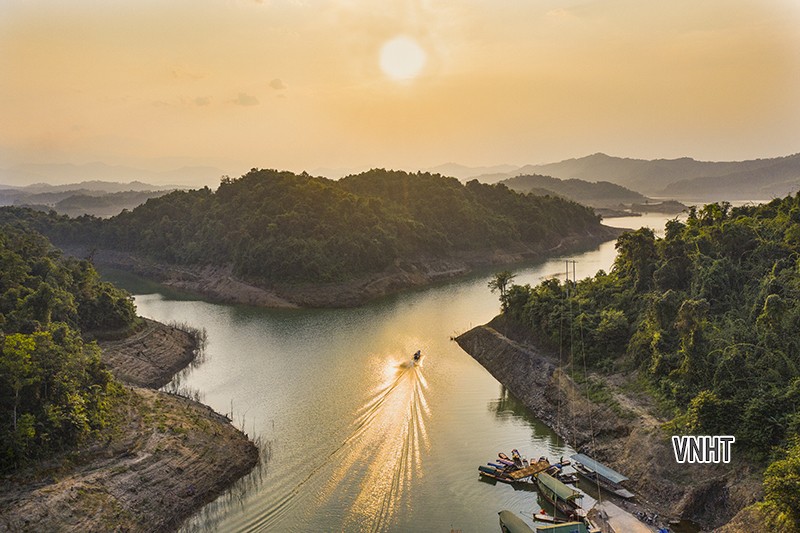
[239, 361, 430, 531]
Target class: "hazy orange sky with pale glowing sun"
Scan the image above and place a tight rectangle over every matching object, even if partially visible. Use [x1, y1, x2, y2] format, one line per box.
[0, 0, 800, 176]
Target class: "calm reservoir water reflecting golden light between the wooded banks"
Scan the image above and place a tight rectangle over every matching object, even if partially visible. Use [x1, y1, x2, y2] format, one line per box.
[100, 215, 672, 533]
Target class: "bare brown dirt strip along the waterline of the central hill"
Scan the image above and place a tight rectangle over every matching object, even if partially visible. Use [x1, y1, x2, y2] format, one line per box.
[62, 226, 623, 307]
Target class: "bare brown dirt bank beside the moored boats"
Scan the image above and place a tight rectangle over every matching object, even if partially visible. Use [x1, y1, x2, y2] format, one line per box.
[456, 317, 761, 531]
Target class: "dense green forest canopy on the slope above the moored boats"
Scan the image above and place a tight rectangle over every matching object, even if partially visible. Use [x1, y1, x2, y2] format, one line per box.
[496, 194, 800, 525]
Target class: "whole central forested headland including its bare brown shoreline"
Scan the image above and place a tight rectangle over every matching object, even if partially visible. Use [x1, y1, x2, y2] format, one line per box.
[0, 169, 619, 307]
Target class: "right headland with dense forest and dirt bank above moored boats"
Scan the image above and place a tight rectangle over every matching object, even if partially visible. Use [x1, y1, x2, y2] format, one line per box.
[456, 194, 800, 532]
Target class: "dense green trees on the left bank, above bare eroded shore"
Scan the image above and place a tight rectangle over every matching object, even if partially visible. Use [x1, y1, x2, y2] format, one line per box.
[0, 225, 136, 472]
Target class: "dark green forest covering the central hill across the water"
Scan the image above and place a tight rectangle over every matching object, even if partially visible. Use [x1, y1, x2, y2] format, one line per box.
[0, 169, 605, 284]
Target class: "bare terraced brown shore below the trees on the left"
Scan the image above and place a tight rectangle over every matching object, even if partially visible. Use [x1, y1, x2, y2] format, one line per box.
[0, 321, 259, 532]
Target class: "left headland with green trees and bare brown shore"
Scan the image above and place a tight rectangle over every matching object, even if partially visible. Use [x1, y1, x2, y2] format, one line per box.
[0, 226, 259, 532]
